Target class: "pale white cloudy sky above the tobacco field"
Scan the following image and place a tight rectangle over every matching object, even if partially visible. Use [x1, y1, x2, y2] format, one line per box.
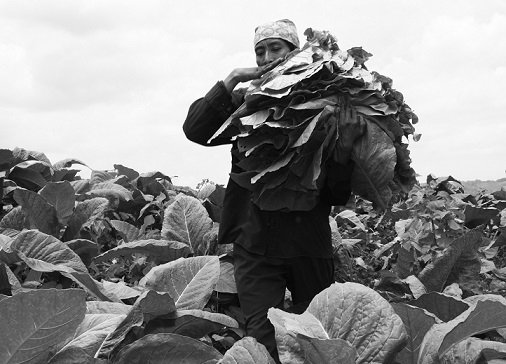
[0, 0, 506, 187]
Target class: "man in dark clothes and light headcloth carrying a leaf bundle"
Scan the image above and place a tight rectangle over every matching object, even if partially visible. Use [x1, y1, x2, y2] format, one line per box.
[183, 19, 363, 361]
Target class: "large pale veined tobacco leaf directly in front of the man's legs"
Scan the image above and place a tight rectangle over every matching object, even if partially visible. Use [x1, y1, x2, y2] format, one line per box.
[268, 283, 407, 363]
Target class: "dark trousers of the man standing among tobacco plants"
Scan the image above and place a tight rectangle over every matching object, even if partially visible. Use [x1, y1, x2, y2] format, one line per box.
[234, 244, 334, 362]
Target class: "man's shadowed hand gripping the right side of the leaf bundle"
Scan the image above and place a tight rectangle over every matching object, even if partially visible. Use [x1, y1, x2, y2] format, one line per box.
[335, 101, 366, 164]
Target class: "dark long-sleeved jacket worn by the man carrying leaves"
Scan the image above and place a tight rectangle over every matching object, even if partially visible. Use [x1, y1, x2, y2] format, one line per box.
[183, 81, 353, 258]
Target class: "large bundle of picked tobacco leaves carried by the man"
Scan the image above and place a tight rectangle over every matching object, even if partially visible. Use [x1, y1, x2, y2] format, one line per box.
[210, 28, 419, 211]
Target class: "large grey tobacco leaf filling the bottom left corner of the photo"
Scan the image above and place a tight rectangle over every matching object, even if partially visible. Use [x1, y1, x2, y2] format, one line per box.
[0, 289, 86, 364]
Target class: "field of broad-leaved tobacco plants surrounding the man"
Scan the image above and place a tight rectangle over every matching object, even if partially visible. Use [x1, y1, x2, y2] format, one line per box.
[0, 148, 506, 364]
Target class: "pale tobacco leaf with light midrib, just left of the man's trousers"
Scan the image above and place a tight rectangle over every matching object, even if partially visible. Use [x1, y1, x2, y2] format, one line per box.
[139, 256, 220, 309]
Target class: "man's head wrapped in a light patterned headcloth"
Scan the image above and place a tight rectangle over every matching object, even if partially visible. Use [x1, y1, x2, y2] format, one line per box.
[254, 19, 299, 66]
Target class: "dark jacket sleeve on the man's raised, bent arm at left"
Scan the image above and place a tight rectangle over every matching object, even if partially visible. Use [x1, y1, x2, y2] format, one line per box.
[183, 81, 242, 146]
